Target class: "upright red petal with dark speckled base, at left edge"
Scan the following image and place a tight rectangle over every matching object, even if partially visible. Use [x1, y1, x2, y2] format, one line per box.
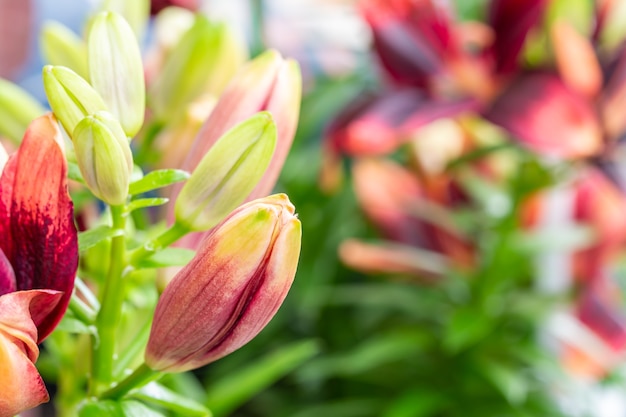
[0, 115, 78, 341]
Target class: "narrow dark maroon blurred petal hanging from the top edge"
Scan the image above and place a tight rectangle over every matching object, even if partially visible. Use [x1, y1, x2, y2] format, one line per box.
[489, 0, 547, 73]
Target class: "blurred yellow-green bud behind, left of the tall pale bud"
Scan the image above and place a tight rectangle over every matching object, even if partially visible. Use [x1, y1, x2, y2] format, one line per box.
[40, 22, 89, 79]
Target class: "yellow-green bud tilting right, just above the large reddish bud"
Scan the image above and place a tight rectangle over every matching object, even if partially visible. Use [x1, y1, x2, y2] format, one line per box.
[175, 112, 276, 231]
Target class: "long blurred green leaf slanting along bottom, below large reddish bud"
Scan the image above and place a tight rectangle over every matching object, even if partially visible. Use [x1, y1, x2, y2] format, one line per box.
[207, 340, 319, 416]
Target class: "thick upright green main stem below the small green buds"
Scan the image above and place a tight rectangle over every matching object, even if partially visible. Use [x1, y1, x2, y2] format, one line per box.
[90, 206, 126, 395]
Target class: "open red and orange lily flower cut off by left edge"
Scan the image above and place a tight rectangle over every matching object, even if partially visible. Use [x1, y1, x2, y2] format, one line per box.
[0, 115, 78, 416]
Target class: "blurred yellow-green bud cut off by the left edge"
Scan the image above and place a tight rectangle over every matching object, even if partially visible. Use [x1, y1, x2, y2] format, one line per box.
[0, 78, 45, 143]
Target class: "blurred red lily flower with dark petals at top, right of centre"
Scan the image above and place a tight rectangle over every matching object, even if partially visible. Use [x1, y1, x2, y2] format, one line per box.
[327, 0, 547, 160]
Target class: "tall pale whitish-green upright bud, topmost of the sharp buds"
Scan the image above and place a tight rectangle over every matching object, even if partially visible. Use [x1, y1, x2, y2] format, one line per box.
[88, 12, 146, 137]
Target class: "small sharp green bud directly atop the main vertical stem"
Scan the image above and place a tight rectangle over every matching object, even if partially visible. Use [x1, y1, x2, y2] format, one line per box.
[72, 112, 133, 205]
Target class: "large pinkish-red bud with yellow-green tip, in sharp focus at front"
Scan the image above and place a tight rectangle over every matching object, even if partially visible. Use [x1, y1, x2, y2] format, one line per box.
[145, 194, 301, 372]
